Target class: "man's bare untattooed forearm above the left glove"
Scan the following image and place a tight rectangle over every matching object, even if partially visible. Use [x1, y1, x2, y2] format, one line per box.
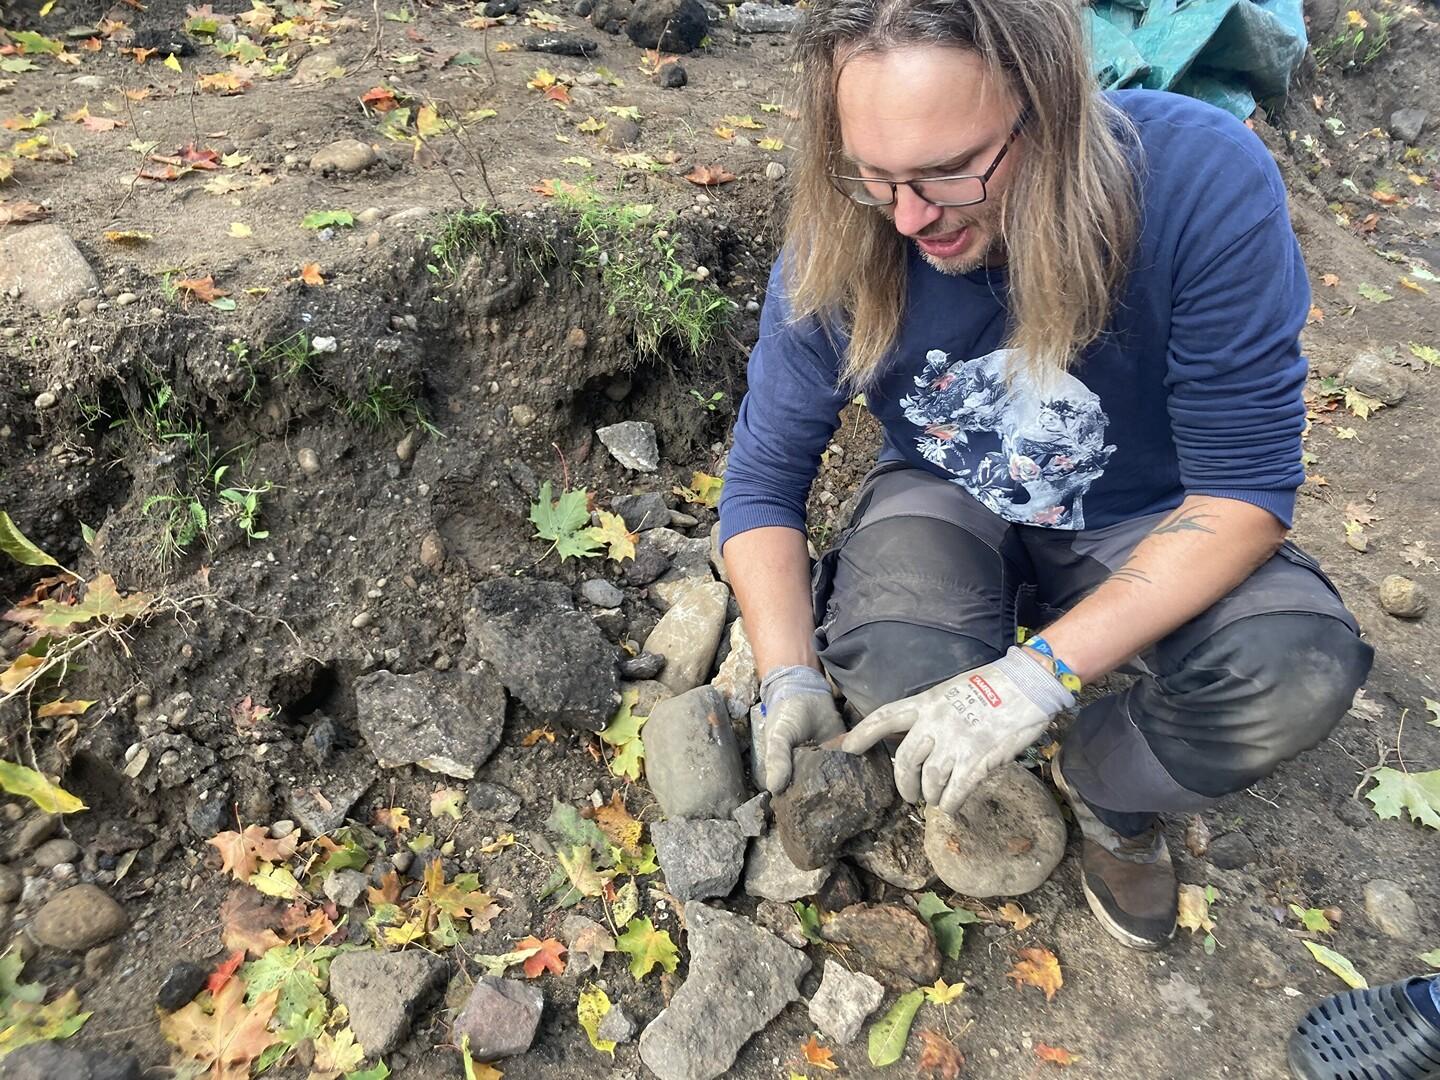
[724, 526, 819, 678]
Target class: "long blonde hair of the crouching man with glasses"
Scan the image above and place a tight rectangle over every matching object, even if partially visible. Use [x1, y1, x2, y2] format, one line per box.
[785, 0, 1139, 390]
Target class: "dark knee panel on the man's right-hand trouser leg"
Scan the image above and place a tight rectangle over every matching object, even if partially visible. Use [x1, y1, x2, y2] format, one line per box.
[1128, 612, 1374, 795]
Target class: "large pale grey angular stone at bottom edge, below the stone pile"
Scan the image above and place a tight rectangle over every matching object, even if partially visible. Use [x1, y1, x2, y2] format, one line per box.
[639, 900, 811, 1080]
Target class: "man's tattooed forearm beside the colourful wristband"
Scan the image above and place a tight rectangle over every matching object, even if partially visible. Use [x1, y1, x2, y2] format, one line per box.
[1044, 495, 1286, 683]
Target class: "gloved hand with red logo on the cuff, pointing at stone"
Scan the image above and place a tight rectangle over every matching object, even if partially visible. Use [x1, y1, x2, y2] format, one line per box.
[840, 647, 1074, 814]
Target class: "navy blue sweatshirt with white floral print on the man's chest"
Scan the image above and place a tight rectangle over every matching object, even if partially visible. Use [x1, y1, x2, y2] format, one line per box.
[720, 91, 1310, 543]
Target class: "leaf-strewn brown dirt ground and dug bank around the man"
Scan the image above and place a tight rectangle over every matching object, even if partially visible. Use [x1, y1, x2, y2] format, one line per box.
[0, 0, 1440, 1080]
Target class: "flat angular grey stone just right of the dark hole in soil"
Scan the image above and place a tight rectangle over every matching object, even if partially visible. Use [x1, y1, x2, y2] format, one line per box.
[354, 667, 505, 780]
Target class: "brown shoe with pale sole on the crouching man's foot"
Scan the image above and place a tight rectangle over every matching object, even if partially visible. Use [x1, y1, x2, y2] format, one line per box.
[1050, 747, 1179, 949]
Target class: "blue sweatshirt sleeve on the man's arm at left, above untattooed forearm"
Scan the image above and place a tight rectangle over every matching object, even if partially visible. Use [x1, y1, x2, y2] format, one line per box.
[720, 255, 845, 546]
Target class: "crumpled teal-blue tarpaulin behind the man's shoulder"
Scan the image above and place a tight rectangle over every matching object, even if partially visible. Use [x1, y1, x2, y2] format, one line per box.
[1086, 0, 1306, 120]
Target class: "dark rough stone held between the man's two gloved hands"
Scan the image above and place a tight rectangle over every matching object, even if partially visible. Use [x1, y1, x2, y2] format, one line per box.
[770, 746, 896, 870]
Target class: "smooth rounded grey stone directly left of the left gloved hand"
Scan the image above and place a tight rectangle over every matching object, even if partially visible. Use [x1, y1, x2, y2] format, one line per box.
[641, 687, 749, 818]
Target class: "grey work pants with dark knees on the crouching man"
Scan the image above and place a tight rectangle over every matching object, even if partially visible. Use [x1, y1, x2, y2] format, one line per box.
[812, 464, 1374, 834]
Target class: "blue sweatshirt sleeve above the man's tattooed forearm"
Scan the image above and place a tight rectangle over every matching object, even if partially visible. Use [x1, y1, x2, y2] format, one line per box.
[1166, 132, 1310, 528]
